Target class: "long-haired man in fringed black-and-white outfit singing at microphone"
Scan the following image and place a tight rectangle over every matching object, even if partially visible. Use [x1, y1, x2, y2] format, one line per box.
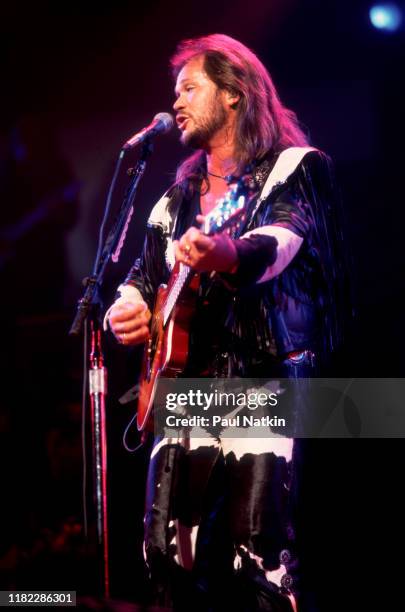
[107, 34, 342, 612]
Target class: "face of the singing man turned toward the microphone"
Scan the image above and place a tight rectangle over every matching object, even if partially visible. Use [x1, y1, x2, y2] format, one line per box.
[173, 56, 227, 148]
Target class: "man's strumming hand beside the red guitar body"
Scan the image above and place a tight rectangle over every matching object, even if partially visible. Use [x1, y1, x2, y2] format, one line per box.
[108, 302, 151, 346]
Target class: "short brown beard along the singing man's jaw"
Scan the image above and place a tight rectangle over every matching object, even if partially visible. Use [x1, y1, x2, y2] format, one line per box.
[180, 91, 227, 149]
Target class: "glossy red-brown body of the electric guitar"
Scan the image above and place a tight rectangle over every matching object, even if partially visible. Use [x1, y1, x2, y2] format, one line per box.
[137, 262, 200, 431]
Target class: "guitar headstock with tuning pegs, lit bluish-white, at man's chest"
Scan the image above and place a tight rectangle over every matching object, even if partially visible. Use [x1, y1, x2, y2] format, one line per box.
[202, 174, 252, 235]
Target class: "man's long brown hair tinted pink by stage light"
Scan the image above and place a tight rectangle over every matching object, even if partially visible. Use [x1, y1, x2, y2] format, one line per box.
[170, 34, 308, 183]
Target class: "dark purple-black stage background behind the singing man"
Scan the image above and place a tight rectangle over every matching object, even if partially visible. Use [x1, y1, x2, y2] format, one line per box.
[0, 0, 405, 610]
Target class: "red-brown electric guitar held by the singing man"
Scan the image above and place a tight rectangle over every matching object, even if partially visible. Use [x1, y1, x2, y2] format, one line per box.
[137, 175, 251, 431]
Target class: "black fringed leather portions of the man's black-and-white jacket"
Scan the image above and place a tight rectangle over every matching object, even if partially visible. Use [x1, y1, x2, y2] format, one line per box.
[125, 151, 346, 376]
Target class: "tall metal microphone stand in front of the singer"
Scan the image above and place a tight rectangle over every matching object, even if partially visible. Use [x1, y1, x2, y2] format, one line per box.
[69, 138, 153, 598]
